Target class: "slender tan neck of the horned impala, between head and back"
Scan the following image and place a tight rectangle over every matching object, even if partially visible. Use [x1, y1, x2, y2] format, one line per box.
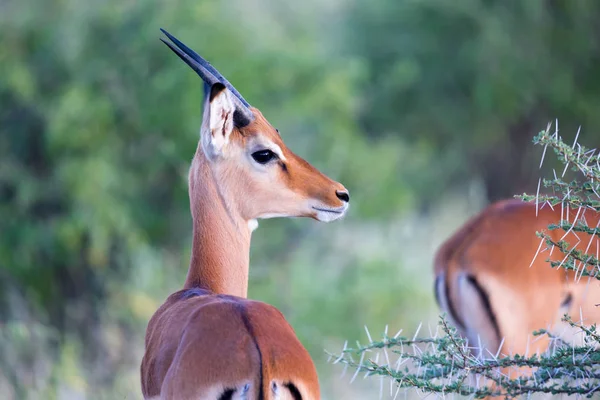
[185, 147, 251, 297]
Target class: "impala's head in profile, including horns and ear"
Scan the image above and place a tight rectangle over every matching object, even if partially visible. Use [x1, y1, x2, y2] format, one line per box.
[162, 30, 350, 222]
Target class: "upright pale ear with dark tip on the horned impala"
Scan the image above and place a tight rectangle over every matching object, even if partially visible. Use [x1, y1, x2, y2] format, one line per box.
[202, 83, 235, 160]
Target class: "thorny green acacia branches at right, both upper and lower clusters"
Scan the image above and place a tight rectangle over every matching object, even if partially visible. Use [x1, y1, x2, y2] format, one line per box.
[335, 125, 600, 398]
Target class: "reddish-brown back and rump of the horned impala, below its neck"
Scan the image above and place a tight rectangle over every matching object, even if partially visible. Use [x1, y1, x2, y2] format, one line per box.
[142, 289, 320, 399]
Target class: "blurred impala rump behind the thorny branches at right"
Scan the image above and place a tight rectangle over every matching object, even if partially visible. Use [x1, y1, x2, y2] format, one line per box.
[434, 200, 600, 384]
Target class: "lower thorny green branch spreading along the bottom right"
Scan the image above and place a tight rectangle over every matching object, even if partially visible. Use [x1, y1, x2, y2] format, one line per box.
[331, 315, 600, 398]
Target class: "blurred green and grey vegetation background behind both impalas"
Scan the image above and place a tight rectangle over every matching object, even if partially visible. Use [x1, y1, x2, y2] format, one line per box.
[0, 0, 600, 399]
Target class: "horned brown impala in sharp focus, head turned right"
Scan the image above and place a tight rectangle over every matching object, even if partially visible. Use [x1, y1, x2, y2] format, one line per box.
[141, 30, 349, 400]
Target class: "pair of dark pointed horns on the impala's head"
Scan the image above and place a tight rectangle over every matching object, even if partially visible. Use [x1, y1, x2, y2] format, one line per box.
[160, 28, 254, 127]
